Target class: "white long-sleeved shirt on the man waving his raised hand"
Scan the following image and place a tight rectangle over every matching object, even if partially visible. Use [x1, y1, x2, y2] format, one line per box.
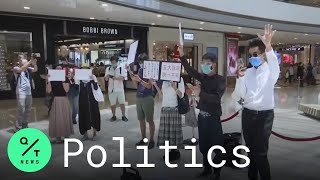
[233, 50, 280, 111]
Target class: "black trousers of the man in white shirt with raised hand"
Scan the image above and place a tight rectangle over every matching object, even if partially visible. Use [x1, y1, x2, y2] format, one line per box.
[242, 109, 274, 180]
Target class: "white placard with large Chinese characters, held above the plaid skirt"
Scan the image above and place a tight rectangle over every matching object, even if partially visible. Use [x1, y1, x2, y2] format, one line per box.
[160, 62, 181, 82]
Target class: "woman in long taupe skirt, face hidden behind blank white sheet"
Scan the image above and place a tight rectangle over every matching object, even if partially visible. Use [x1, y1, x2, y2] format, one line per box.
[47, 66, 74, 144]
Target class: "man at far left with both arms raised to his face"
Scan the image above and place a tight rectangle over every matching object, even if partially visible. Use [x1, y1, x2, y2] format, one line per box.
[13, 55, 38, 131]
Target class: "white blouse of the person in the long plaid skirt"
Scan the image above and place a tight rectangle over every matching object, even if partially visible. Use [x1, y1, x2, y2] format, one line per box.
[161, 78, 185, 107]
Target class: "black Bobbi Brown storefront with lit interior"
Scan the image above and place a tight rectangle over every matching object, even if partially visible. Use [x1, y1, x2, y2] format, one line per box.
[0, 16, 148, 99]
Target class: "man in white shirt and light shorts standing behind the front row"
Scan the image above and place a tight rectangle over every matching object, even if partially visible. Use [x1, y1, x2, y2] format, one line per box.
[105, 56, 128, 122]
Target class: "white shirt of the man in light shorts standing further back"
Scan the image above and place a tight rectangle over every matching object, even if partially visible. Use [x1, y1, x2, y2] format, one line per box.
[105, 67, 127, 92]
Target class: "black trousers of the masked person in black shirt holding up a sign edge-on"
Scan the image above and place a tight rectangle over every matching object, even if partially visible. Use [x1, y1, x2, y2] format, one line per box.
[198, 114, 223, 171]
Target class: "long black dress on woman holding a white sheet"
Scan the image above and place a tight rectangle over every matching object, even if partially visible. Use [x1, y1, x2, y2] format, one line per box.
[79, 80, 101, 135]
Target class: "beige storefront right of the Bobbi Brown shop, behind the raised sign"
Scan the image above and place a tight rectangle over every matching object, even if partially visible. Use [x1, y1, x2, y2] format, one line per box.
[148, 27, 225, 83]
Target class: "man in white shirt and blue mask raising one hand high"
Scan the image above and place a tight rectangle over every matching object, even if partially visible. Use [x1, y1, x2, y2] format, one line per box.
[235, 25, 280, 180]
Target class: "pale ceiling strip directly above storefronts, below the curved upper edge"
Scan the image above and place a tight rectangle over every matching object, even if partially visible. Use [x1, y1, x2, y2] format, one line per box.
[0, 0, 320, 44]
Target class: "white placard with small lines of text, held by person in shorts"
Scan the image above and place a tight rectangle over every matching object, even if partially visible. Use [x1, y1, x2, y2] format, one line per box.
[143, 61, 160, 80]
